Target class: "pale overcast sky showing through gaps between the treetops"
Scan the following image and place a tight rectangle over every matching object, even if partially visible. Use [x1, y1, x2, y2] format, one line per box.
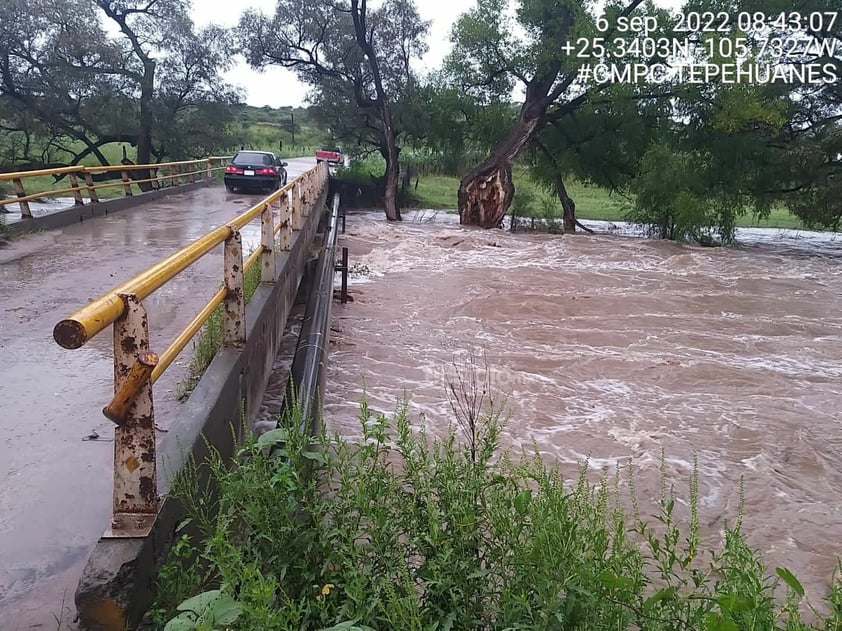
[199, 0, 680, 107]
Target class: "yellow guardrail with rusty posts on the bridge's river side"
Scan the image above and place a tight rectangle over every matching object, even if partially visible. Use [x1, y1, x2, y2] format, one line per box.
[53, 164, 328, 537]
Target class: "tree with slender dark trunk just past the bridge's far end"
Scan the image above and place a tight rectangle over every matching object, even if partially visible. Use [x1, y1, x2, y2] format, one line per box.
[239, 0, 427, 221]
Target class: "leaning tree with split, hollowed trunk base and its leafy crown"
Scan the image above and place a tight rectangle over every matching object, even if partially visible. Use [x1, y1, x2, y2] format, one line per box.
[448, 0, 654, 228]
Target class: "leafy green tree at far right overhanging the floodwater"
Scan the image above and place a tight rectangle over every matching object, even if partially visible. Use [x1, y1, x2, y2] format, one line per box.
[630, 0, 842, 242]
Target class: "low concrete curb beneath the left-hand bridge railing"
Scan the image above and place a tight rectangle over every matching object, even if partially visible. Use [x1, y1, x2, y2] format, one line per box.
[6, 179, 214, 237]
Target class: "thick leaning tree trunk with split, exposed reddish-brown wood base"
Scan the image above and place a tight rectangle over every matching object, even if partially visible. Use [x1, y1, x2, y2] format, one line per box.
[459, 115, 540, 228]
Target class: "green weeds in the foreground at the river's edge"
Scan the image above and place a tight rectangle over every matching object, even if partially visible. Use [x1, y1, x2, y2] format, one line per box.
[151, 398, 842, 631]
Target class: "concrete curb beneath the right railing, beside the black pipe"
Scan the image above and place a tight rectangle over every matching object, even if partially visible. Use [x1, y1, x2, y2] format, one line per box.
[76, 185, 327, 631]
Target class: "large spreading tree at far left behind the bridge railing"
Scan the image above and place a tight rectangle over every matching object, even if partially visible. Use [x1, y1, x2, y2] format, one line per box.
[0, 0, 234, 169]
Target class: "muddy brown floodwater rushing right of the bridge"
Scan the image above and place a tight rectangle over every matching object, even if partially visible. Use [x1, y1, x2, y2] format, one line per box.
[308, 214, 842, 600]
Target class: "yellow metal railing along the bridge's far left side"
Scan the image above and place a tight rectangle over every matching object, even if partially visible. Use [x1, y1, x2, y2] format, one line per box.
[0, 156, 229, 218]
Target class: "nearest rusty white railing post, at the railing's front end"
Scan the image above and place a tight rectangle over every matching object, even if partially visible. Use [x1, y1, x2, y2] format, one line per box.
[105, 294, 158, 537]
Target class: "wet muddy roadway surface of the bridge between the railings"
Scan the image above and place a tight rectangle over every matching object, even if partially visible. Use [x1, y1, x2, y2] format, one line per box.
[0, 159, 314, 631]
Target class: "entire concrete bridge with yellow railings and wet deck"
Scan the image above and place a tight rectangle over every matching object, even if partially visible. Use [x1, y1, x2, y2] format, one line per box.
[0, 158, 338, 631]
